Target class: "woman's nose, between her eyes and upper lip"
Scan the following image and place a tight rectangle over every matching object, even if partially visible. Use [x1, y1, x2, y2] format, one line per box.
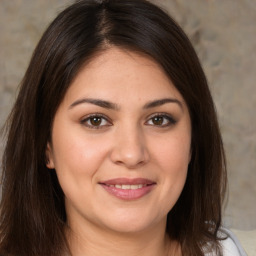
[110, 124, 149, 169]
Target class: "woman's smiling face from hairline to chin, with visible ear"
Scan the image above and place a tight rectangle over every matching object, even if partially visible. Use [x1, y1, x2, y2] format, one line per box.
[47, 48, 191, 235]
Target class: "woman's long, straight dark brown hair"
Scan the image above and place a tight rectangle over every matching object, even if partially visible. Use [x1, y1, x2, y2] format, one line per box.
[0, 0, 226, 256]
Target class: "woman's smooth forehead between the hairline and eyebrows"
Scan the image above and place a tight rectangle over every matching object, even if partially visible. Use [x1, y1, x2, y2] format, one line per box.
[62, 47, 186, 103]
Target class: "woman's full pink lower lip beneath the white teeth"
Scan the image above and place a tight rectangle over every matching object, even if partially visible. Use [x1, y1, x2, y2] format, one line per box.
[100, 184, 155, 200]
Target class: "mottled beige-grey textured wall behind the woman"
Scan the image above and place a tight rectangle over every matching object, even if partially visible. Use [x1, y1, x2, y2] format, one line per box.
[0, 0, 256, 229]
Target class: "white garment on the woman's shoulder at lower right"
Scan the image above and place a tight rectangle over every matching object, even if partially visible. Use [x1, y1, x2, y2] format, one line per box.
[220, 228, 247, 256]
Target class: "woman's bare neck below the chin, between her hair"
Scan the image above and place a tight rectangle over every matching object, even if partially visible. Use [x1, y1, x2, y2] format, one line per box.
[67, 218, 180, 256]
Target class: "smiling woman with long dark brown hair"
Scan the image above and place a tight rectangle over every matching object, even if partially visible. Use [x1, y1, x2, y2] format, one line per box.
[0, 0, 246, 256]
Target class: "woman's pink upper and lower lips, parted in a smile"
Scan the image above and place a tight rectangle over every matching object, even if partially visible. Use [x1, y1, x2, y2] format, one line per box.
[99, 178, 156, 200]
